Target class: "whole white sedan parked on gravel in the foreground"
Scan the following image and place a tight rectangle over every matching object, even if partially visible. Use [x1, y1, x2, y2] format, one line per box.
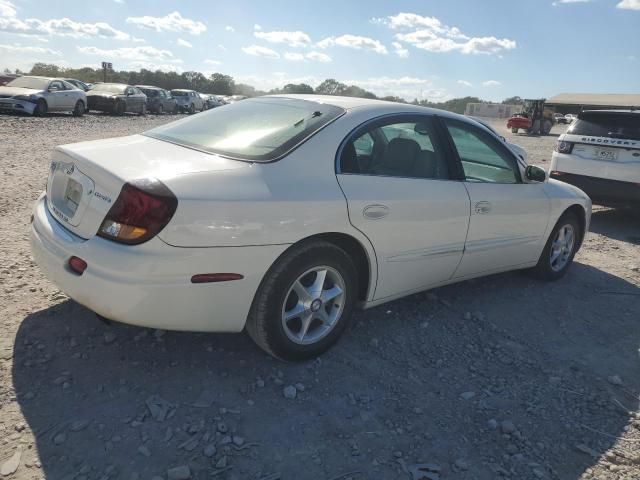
[31, 95, 591, 360]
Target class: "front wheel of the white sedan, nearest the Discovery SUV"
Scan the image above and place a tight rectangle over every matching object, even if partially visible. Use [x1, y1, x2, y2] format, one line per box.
[533, 212, 582, 280]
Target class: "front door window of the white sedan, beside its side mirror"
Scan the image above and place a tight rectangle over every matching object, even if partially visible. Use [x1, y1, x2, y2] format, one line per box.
[445, 120, 519, 183]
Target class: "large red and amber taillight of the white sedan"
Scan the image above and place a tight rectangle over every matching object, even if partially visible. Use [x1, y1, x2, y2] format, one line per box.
[98, 180, 178, 245]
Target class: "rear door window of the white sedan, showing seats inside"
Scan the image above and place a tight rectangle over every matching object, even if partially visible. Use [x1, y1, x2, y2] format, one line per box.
[340, 117, 449, 179]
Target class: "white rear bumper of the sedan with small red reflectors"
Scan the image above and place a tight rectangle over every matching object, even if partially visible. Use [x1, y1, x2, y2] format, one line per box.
[30, 194, 286, 332]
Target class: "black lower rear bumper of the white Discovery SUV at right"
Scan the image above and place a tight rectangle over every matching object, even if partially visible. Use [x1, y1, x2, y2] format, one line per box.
[549, 171, 640, 207]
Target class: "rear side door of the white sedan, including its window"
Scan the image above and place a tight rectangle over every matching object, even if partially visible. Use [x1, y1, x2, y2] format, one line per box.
[337, 114, 469, 299]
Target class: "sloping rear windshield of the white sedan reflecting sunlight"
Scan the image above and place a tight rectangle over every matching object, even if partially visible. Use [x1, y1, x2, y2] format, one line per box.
[144, 97, 344, 162]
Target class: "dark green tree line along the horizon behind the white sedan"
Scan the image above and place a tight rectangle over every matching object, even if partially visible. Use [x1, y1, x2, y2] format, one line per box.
[16, 63, 522, 113]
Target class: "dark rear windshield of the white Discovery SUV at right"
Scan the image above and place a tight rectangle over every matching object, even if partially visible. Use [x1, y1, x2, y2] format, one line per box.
[567, 112, 640, 140]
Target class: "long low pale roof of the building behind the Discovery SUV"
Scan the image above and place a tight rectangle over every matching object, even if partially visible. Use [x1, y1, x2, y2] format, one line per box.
[545, 93, 640, 113]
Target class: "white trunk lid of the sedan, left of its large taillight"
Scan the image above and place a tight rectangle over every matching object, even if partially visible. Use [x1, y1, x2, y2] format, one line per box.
[47, 135, 249, 239]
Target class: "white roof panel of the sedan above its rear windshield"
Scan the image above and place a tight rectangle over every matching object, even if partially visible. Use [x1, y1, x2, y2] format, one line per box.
[267, 94, 469, 121]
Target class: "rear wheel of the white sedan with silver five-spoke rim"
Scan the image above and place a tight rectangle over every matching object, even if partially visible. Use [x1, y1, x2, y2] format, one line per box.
[246, 241, 358, 361]
